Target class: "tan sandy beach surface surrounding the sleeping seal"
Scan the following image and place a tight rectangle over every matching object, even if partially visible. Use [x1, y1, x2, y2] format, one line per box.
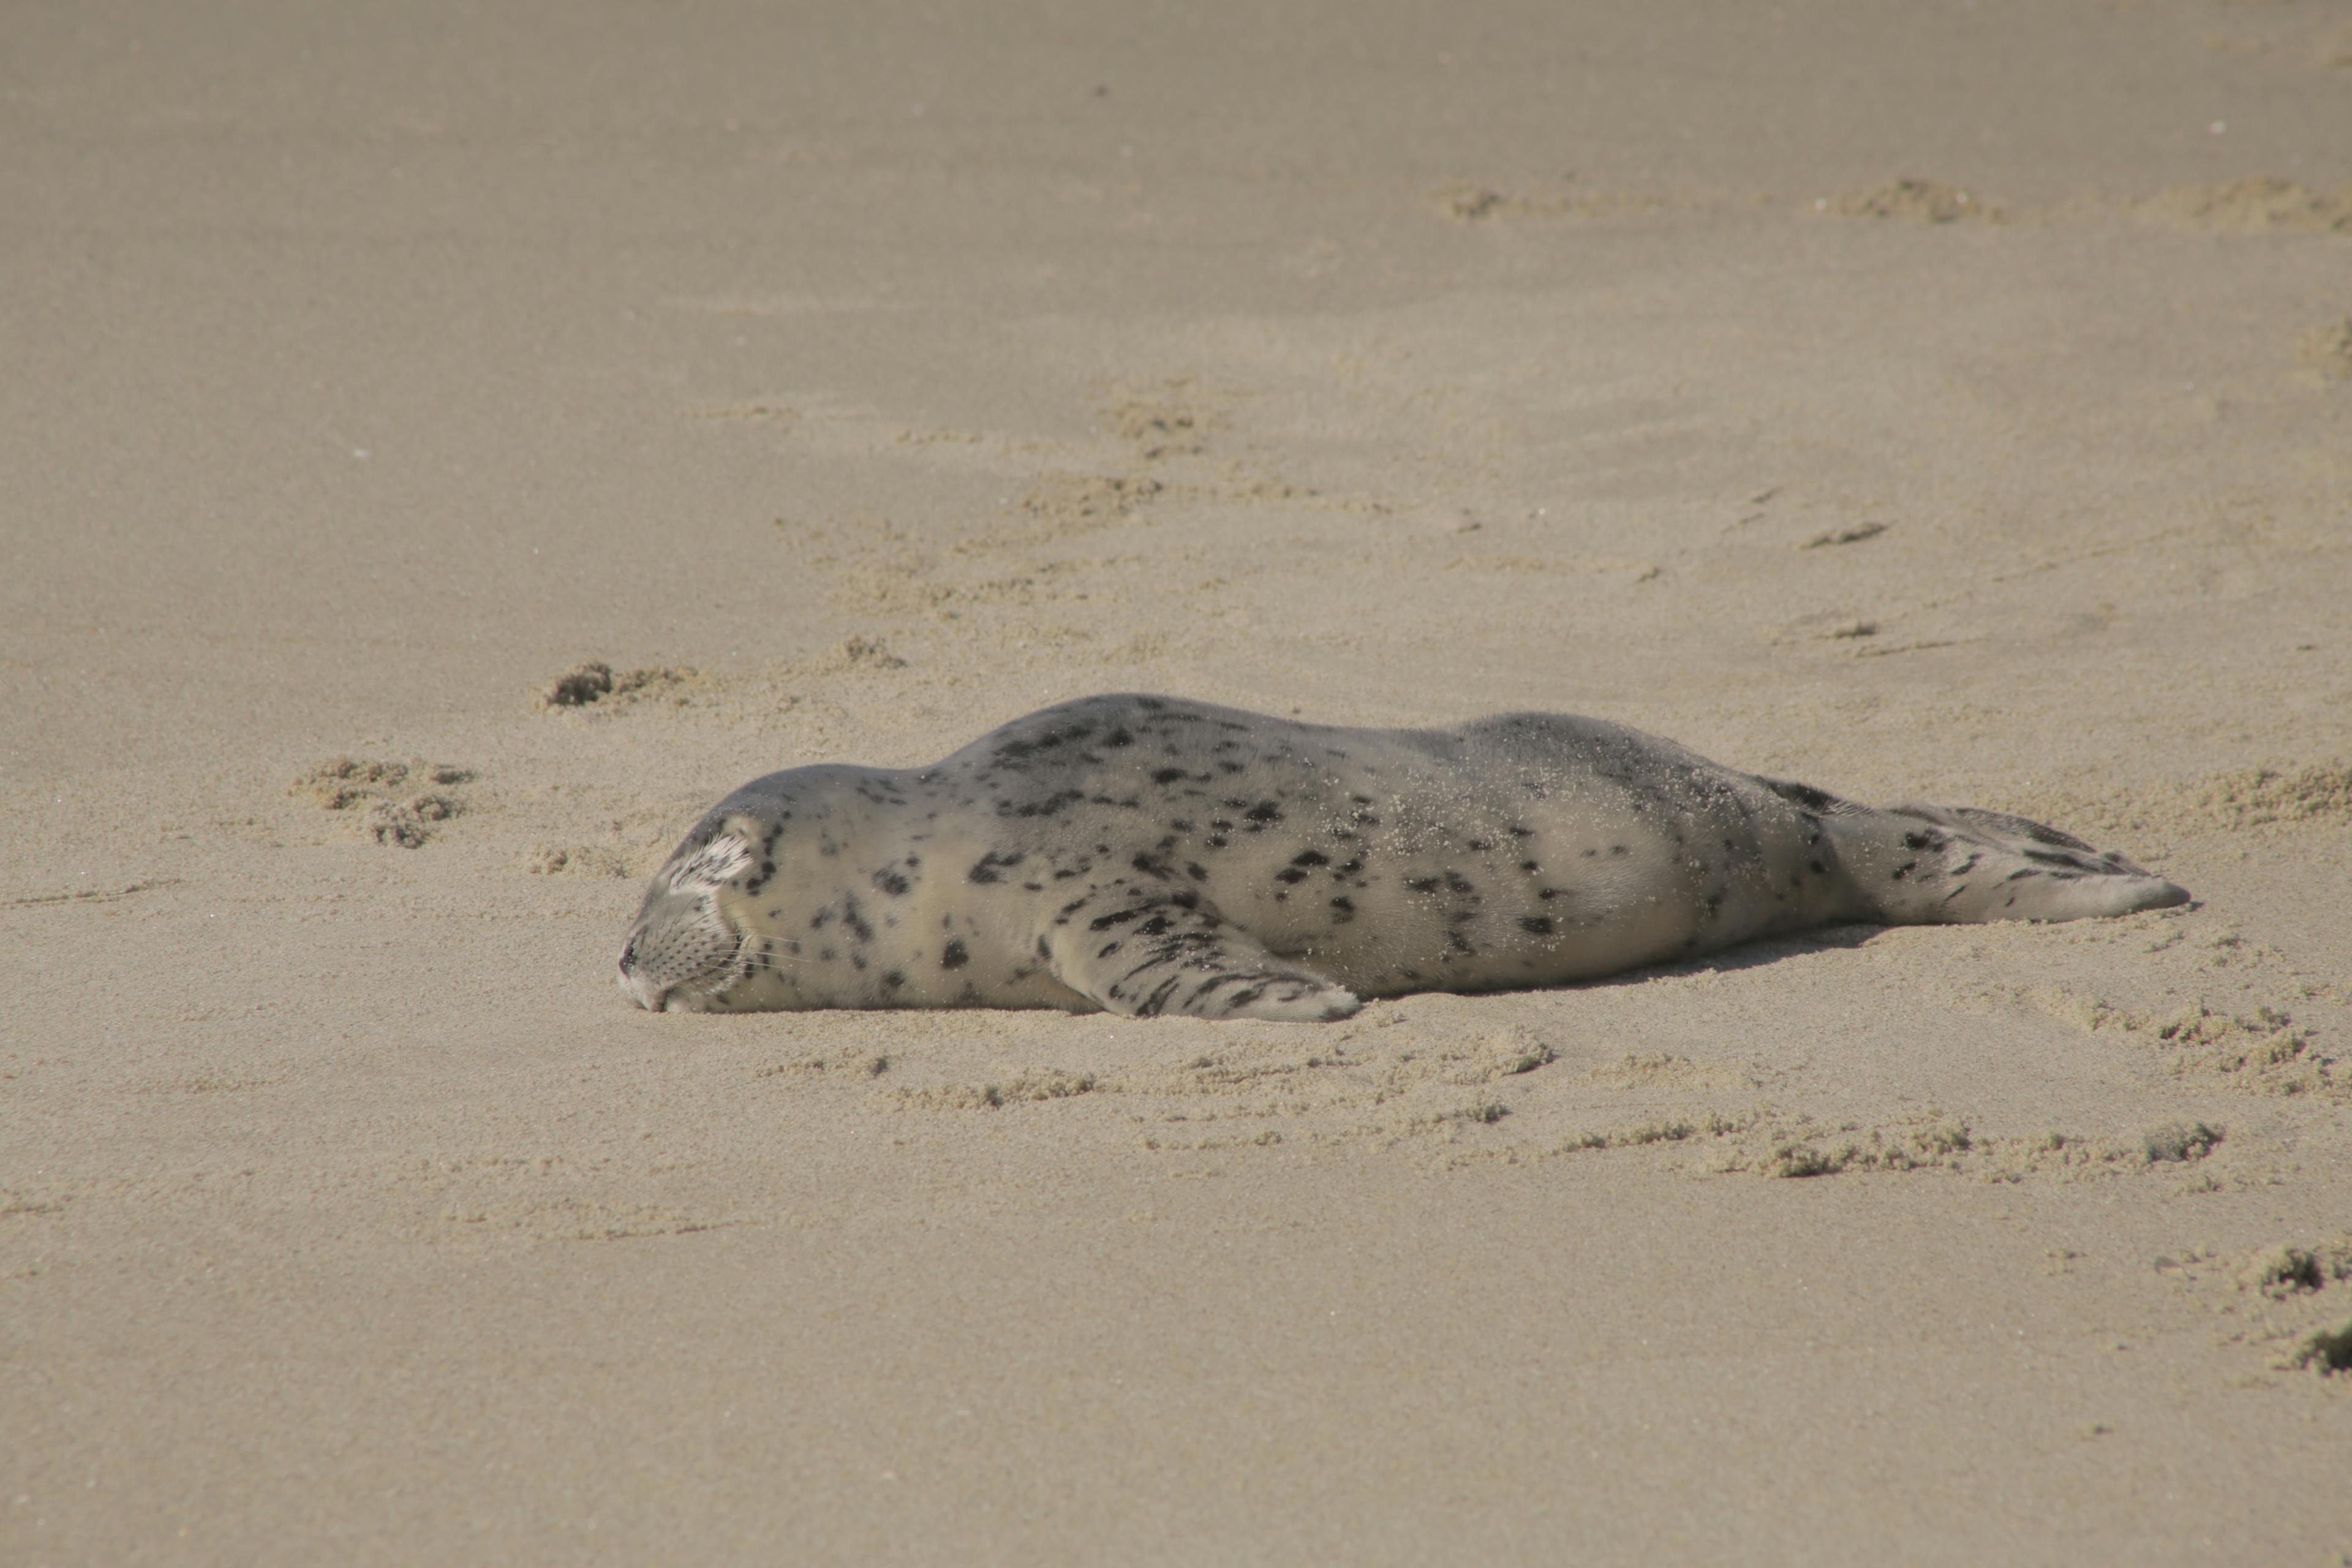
[0, 0, 2352, 1566]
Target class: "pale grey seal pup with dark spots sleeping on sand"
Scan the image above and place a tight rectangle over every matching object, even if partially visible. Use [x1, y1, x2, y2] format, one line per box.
[621, 696, 2187, 1020]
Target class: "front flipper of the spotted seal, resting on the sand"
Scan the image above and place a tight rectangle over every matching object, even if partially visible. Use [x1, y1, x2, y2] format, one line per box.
[1037, 889, 1362, 1023]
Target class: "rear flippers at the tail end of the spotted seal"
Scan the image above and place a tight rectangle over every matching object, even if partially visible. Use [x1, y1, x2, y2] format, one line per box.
[1825, 806, 2190, 926]
